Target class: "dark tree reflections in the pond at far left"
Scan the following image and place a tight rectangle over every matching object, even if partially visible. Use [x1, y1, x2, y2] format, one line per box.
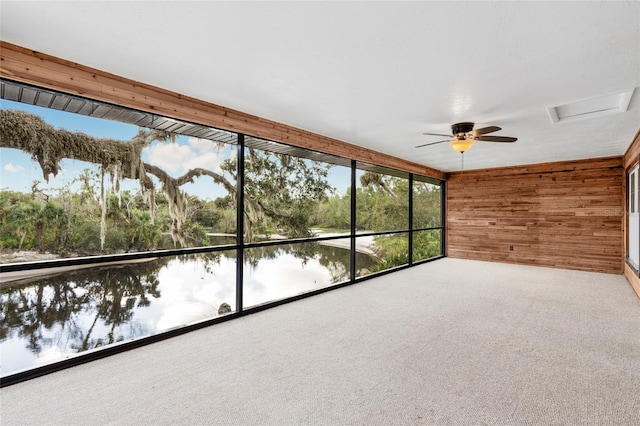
[0, 258, 168, 354]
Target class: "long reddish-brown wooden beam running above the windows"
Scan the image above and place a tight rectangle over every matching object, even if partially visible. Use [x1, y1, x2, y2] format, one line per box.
[0, 41, 445, 179]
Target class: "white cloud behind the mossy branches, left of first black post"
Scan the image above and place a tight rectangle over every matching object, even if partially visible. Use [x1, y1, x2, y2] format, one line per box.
[146, 138, 222, 174]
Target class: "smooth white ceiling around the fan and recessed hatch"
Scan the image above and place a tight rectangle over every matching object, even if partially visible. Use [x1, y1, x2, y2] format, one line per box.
[0, 0, 640, 171]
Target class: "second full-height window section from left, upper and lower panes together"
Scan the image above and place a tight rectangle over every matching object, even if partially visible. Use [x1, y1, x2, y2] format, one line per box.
[243, 137, 351, 308]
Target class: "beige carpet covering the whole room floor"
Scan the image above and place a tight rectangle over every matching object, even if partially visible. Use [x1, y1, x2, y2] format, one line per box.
[0, 259, 640, 425]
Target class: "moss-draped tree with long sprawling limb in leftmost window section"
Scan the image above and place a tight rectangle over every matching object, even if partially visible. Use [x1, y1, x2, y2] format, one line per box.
[0, 110, 225, 251]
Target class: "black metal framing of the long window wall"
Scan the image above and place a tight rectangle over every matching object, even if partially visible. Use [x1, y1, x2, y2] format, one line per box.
[0, 79, 446, 387]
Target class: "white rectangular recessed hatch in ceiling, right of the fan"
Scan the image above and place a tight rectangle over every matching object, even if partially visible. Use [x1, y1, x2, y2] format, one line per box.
[547, 89, 635, 124]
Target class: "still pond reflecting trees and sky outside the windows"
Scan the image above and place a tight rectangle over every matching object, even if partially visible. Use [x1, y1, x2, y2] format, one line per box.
[0, 239, 376, 376]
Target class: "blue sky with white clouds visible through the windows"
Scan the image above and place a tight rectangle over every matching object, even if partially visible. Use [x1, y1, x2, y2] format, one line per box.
[0, 100, 350, 200]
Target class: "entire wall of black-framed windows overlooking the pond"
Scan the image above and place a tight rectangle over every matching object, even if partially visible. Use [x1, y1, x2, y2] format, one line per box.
[0, 81, 444, 377]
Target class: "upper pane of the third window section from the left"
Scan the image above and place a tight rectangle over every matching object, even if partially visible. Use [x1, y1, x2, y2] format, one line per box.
[356, 165, 409, 232]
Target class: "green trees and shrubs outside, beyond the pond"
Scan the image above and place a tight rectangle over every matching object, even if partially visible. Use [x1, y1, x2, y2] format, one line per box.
[0, 106, 441, 264]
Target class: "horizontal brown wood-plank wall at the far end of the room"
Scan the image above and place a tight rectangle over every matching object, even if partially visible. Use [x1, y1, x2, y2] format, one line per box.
[447, 157, 624, 274]
